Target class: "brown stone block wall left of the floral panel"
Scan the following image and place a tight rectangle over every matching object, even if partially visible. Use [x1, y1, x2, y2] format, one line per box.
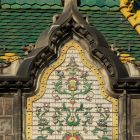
[0, 94, 22, 140]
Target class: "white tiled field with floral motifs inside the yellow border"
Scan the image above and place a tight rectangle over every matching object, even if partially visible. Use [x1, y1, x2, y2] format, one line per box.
[33, 47, 116, 140]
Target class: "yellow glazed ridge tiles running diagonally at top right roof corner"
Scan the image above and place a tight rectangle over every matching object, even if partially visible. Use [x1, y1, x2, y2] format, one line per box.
[120, 0, 140, 34]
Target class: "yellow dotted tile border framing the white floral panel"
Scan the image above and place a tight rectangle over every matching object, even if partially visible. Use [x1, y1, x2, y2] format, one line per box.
[26, 40, 118, 140]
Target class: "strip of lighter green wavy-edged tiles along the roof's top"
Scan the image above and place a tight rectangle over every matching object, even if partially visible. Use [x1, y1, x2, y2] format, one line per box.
[1, 0, 119, 9]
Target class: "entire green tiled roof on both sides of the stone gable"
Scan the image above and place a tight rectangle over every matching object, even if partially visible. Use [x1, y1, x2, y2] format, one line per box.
[0, 0, 140, 60]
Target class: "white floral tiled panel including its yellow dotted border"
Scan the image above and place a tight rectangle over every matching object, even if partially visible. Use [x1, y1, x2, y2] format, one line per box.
[26, 41, 118, 140]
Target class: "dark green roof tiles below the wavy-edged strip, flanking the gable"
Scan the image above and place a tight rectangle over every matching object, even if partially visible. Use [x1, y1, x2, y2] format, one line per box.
[0, 8, 140, 60]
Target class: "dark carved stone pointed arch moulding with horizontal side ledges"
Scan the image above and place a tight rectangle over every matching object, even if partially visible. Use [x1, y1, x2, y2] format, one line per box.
[0, 0, 140, 92]
